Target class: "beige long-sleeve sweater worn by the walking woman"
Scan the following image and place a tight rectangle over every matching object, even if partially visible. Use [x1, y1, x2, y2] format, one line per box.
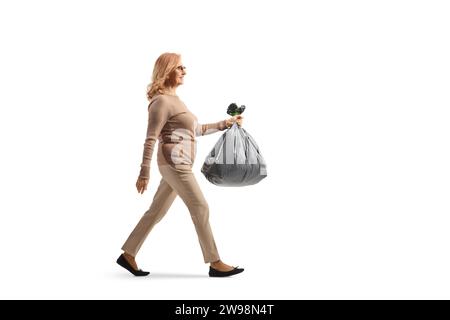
[139, 95, 227, 179]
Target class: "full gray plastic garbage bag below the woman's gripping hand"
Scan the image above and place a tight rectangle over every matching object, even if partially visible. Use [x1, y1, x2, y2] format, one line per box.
[201, 123, 267, 187]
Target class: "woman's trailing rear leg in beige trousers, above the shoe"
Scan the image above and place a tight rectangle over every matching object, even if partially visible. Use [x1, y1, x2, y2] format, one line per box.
[122, 178, 177, 257]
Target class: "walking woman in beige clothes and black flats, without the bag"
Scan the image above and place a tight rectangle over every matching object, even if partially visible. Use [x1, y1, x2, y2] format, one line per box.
[117, 53, 244, 277]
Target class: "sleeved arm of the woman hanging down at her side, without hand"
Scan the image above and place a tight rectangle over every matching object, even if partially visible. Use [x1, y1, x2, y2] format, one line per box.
[139, 96, 170, 179]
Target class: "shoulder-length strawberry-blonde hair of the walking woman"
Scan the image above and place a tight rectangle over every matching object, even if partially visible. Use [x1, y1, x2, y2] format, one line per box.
[147, 52, 181, 101]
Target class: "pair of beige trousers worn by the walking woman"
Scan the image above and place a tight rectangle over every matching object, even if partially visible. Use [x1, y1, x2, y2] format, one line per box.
[122, 165, 220, 263]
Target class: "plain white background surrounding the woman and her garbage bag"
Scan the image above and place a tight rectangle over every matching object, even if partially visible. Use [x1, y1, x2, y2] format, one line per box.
[0, 0, 450, 299]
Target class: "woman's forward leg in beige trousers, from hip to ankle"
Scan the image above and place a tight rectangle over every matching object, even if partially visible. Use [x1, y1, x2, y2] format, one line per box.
[159, 165, 220, 263]
